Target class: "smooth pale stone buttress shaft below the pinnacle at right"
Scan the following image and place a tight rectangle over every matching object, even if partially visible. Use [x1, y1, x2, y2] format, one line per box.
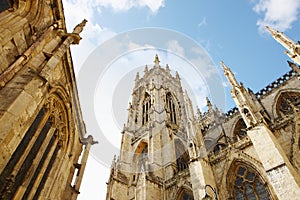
[247, 123, 300, 200]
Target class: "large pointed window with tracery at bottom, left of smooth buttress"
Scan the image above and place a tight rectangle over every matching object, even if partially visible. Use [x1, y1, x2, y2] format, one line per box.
[229, 163, 270, 200]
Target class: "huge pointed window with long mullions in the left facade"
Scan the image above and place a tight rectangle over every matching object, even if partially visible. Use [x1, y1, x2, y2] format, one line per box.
[0, 95, 67, 199]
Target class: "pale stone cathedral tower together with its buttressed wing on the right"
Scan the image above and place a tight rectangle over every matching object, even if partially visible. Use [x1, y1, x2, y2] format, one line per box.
[106, 27, 300, 200]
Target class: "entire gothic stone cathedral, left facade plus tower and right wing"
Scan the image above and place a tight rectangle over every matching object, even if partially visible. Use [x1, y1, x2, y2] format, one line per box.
[0, 0, 300, 200]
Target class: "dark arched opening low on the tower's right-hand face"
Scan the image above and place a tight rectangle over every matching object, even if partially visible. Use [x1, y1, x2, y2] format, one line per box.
[175, 139, 190, 172]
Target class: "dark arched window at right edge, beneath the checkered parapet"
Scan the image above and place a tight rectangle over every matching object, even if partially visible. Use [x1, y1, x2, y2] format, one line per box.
[276, 92, 300, 115]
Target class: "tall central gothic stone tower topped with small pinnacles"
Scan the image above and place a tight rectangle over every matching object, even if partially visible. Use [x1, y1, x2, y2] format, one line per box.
[106, 56, 215, 200]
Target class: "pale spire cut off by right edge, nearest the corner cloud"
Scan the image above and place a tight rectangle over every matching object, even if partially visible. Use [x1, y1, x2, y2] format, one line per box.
[266, 26, 300, 65]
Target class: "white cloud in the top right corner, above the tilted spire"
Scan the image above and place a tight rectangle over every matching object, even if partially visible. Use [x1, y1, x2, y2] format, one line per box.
[253, 0, 300, 32]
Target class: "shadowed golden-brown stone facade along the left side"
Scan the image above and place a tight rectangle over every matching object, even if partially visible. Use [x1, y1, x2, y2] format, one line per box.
[0, 0, 93, 199]
